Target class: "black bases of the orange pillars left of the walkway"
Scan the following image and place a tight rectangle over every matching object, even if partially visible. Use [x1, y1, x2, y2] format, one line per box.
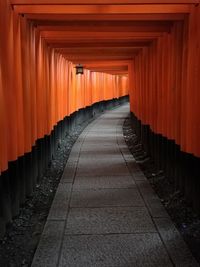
[0, 96, 128, 237]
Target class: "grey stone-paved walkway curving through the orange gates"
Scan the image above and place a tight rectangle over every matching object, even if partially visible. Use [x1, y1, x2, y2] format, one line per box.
[32, 105, 199, 267]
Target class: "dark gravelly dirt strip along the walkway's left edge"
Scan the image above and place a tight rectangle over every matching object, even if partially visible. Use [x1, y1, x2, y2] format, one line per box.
[0, 123, 88, 267]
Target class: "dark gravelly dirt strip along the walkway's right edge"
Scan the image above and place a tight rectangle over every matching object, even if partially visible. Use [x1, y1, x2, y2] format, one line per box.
[123, 117, 200, 264]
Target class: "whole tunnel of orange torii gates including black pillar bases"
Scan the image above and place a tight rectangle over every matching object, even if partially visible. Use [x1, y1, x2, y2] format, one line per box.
[0, 0, 200, 234]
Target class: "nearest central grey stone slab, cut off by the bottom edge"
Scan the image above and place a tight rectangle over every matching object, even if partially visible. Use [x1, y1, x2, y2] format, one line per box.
[59, 234, 173, 267]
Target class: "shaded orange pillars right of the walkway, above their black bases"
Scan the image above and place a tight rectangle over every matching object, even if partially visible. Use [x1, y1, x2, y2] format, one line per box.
[129, 7, 200, 160]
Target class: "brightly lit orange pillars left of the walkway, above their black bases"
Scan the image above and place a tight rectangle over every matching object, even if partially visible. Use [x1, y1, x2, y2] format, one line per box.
[0, 0, 128, 172]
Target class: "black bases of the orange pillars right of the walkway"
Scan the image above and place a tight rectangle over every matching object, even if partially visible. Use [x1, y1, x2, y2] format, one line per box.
[131, 113, 200, 214]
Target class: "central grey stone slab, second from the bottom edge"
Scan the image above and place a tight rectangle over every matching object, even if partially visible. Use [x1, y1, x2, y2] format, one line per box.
[65, 207, 156, 235]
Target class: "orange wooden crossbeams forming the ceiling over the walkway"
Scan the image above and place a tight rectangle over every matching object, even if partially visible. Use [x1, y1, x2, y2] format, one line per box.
[11, 0, 199, 75]
